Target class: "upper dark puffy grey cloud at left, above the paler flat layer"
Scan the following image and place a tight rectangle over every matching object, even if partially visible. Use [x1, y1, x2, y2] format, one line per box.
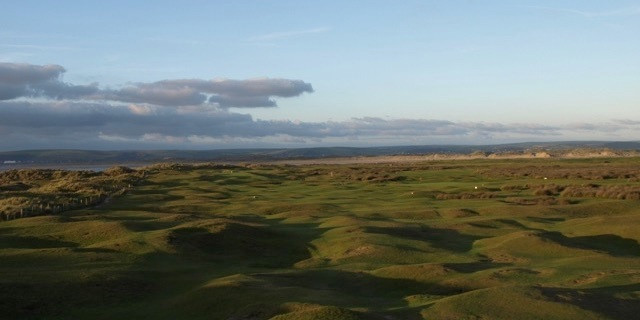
[0, 63, 313, 108]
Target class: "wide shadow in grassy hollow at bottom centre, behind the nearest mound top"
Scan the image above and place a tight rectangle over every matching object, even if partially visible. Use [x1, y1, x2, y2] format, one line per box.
[178, 270, 467, 319]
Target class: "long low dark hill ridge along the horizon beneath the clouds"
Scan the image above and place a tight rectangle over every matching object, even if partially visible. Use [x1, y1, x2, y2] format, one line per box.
[0, 141, 640, 164]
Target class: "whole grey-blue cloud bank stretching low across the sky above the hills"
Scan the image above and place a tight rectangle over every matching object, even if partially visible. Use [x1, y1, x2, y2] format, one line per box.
[0, 63, 638, 149]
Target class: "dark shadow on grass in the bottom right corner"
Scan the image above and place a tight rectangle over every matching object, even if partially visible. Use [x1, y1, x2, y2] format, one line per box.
[538, 283, 640, 320]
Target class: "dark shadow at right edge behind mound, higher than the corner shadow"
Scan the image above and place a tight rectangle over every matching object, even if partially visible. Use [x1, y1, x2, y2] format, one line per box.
[539, 232, 640, 257]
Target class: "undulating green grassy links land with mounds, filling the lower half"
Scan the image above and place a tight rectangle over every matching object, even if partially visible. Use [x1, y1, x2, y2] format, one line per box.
[0, 158, 640, 320]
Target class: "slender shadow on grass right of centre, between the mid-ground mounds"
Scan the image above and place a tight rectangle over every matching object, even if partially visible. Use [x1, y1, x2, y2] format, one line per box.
[365, 225, 483, 252]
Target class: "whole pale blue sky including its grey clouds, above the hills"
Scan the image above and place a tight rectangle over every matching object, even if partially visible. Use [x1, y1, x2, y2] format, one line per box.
[0, 0, 640, 150]
